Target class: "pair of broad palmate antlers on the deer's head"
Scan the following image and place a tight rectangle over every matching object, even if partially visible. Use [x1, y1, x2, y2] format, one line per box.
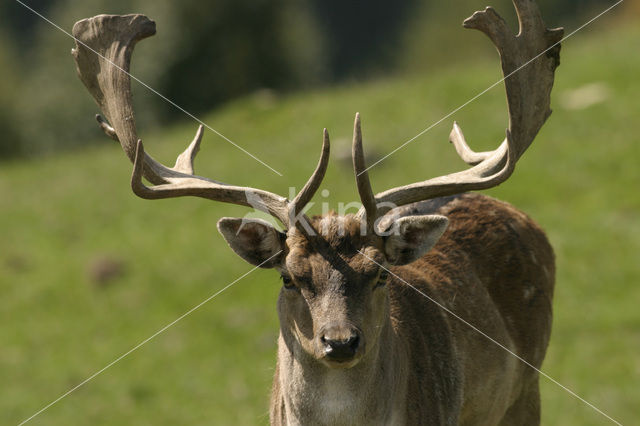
[73, 0, 563, 233]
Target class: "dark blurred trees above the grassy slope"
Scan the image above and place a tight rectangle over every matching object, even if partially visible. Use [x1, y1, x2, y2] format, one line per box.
[0, 0, 624, 159]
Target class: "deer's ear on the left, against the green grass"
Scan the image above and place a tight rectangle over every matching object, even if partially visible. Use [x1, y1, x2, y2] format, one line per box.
[218, 217, 287, 268]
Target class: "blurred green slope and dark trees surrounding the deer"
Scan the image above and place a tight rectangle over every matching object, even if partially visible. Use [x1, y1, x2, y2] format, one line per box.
[0, 0, 640, 425]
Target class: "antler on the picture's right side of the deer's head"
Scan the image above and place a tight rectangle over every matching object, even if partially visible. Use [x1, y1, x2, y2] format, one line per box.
[353, 0, 564, 230]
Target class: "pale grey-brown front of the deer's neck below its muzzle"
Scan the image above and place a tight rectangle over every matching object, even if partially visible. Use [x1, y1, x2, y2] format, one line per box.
[274, 312, 407, 425]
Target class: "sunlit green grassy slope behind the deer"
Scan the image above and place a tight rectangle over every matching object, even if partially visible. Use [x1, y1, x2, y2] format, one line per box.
[0, 15, 640, 425]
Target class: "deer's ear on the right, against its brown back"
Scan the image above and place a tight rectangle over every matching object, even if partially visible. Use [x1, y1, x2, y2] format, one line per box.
[381, 215, 449, 265]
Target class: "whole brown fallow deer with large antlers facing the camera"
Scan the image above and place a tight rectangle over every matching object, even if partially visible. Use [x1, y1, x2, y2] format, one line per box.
[73, 0, 562, 425]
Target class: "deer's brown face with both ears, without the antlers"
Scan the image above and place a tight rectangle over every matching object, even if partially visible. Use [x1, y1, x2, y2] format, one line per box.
[218, 211, 447, 368]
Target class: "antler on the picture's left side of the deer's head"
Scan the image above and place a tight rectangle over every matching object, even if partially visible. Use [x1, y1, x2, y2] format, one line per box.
[72, 15, 330, 229]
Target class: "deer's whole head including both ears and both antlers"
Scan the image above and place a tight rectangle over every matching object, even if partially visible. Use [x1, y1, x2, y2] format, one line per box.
[73, 0, 562, 368]
